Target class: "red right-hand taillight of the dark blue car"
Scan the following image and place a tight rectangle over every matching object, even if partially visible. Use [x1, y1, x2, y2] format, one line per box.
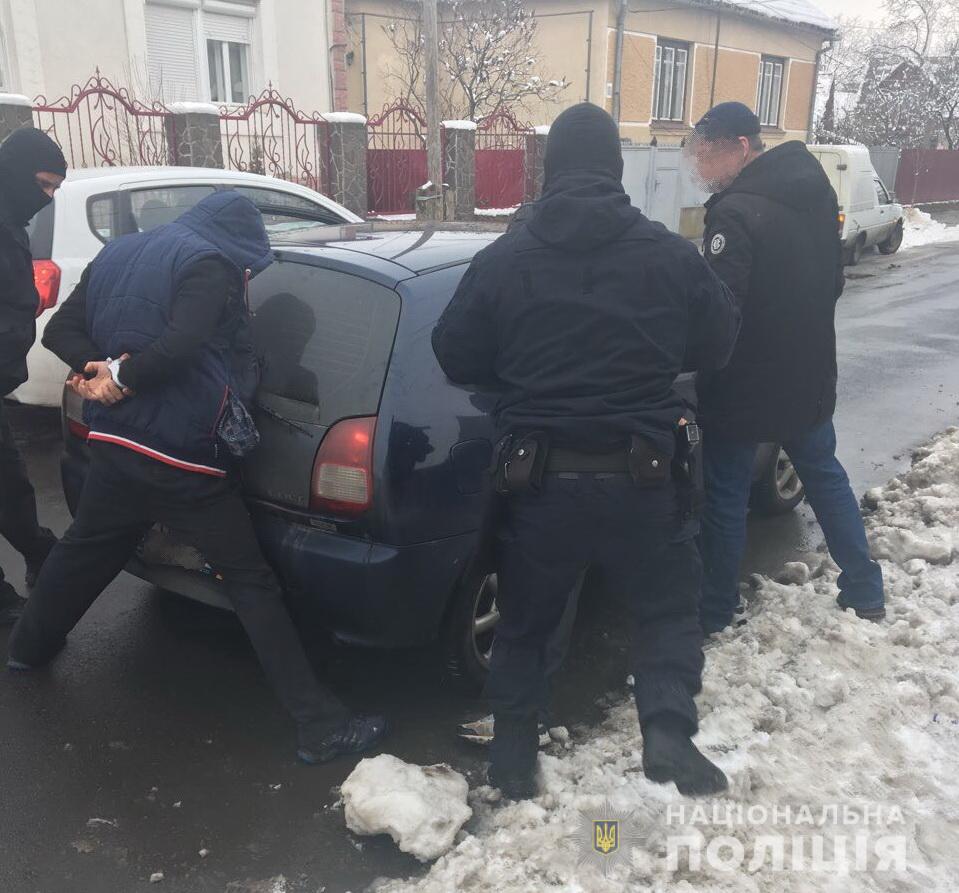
[310, 417, 376, 518]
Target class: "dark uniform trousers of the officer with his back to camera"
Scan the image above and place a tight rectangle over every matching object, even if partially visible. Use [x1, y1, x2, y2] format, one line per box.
[486, 475, 703, 772]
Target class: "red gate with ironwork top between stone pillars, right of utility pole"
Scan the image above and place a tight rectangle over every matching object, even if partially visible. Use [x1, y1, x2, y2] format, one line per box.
[476, 108, 533, 208]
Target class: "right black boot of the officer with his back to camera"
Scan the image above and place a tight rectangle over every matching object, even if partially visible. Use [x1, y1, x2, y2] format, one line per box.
[643, 713, 729, 797]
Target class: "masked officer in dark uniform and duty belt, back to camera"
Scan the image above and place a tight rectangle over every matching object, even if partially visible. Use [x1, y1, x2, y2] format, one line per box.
[433, 103, 739, 798]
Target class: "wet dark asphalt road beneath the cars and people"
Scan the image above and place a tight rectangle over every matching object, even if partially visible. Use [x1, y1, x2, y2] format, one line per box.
[0, 235, 959, 893]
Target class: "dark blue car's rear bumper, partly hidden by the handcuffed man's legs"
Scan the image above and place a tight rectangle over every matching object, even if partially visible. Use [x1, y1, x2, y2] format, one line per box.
[61, 451, 476, 647]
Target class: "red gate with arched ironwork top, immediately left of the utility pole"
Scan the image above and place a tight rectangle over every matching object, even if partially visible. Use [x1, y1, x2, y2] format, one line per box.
[366, 101, 428, 214]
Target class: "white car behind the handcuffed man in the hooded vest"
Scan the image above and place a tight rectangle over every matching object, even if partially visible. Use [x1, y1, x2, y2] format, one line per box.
[11, 167, 363, 406]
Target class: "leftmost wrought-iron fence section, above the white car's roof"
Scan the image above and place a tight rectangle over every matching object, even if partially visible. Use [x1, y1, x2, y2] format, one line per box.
[33, 70, 176, 167]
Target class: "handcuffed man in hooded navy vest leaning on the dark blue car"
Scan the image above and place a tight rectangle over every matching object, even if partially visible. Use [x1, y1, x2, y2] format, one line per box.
[8, 191, 385, 763]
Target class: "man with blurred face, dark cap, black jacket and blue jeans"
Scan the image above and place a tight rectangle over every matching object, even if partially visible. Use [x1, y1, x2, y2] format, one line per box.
[688, 103, 885, 633]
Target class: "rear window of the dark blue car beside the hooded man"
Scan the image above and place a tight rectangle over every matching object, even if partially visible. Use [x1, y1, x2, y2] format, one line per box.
[250, 261, 400, 425]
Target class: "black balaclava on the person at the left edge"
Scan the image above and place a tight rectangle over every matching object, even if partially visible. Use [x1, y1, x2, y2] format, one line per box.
[0, 127, 67, 226]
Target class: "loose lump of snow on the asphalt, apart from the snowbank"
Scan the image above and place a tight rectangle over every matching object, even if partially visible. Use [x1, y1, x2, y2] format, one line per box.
[341, 754, 473, 862]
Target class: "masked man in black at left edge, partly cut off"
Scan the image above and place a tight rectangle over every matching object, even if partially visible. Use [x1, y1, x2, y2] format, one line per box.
[0, 127, 67, 626]
